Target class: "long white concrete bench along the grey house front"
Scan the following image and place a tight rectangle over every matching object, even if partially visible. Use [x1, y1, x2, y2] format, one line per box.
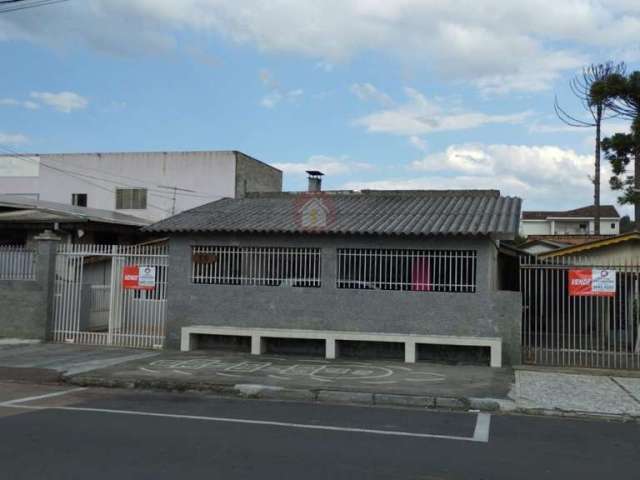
[180, 325, 502, 367]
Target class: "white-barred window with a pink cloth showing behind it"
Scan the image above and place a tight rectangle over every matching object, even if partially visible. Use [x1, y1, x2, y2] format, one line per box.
[337, 248, 477, 293]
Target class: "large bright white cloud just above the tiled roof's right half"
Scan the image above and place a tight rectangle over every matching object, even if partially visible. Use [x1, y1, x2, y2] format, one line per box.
[343, 144, 616, 209]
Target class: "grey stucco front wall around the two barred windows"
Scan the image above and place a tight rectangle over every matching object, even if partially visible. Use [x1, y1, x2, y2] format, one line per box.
[167, 235, 520, 363]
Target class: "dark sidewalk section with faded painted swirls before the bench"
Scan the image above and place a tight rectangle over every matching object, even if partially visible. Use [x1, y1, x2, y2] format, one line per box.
[63, 351, 514, 409]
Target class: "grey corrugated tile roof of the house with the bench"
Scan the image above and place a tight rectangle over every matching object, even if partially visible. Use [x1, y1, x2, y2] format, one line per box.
[145, 190, 521, 238]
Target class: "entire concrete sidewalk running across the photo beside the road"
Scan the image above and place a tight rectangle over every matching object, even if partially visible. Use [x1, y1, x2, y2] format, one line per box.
[0, 344, 640, 419]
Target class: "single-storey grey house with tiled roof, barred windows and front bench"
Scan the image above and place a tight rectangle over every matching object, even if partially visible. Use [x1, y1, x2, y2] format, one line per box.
[145, 186, 521, 366]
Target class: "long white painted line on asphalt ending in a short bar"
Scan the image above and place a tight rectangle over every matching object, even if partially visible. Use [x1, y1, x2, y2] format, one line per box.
[0, 402, 490, 443]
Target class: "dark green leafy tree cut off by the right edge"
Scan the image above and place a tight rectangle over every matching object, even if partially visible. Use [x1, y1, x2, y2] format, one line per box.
[602, 71, 640, 229]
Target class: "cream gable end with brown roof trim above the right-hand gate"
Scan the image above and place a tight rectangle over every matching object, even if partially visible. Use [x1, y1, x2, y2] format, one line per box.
[539, 232, 640, 266]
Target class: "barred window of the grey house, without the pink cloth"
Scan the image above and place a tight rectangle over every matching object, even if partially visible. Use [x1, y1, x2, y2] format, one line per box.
[191, 246, 321, 287]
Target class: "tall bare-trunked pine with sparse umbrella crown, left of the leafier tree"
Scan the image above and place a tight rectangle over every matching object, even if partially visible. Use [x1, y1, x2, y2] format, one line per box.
[554, 62, 626, 235]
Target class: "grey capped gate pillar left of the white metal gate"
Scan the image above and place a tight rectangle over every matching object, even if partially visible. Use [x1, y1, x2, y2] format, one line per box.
[34, 230, 60, 340]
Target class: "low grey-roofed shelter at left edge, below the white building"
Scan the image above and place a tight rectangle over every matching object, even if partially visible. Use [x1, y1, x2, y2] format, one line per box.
[0, 195, 150, 246]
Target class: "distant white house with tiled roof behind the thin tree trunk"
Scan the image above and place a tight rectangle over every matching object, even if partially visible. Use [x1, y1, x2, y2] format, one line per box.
[520, 205, 620, 237]
